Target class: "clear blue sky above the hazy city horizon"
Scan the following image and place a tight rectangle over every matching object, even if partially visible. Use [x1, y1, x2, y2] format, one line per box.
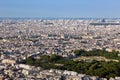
[0, 0, 120, 18]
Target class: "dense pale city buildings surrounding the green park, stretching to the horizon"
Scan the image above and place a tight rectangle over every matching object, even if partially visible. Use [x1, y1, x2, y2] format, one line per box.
[0, 18, 120, 80]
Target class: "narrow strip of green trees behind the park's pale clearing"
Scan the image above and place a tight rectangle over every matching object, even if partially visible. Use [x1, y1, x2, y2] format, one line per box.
[74, 49, 120, 60]
